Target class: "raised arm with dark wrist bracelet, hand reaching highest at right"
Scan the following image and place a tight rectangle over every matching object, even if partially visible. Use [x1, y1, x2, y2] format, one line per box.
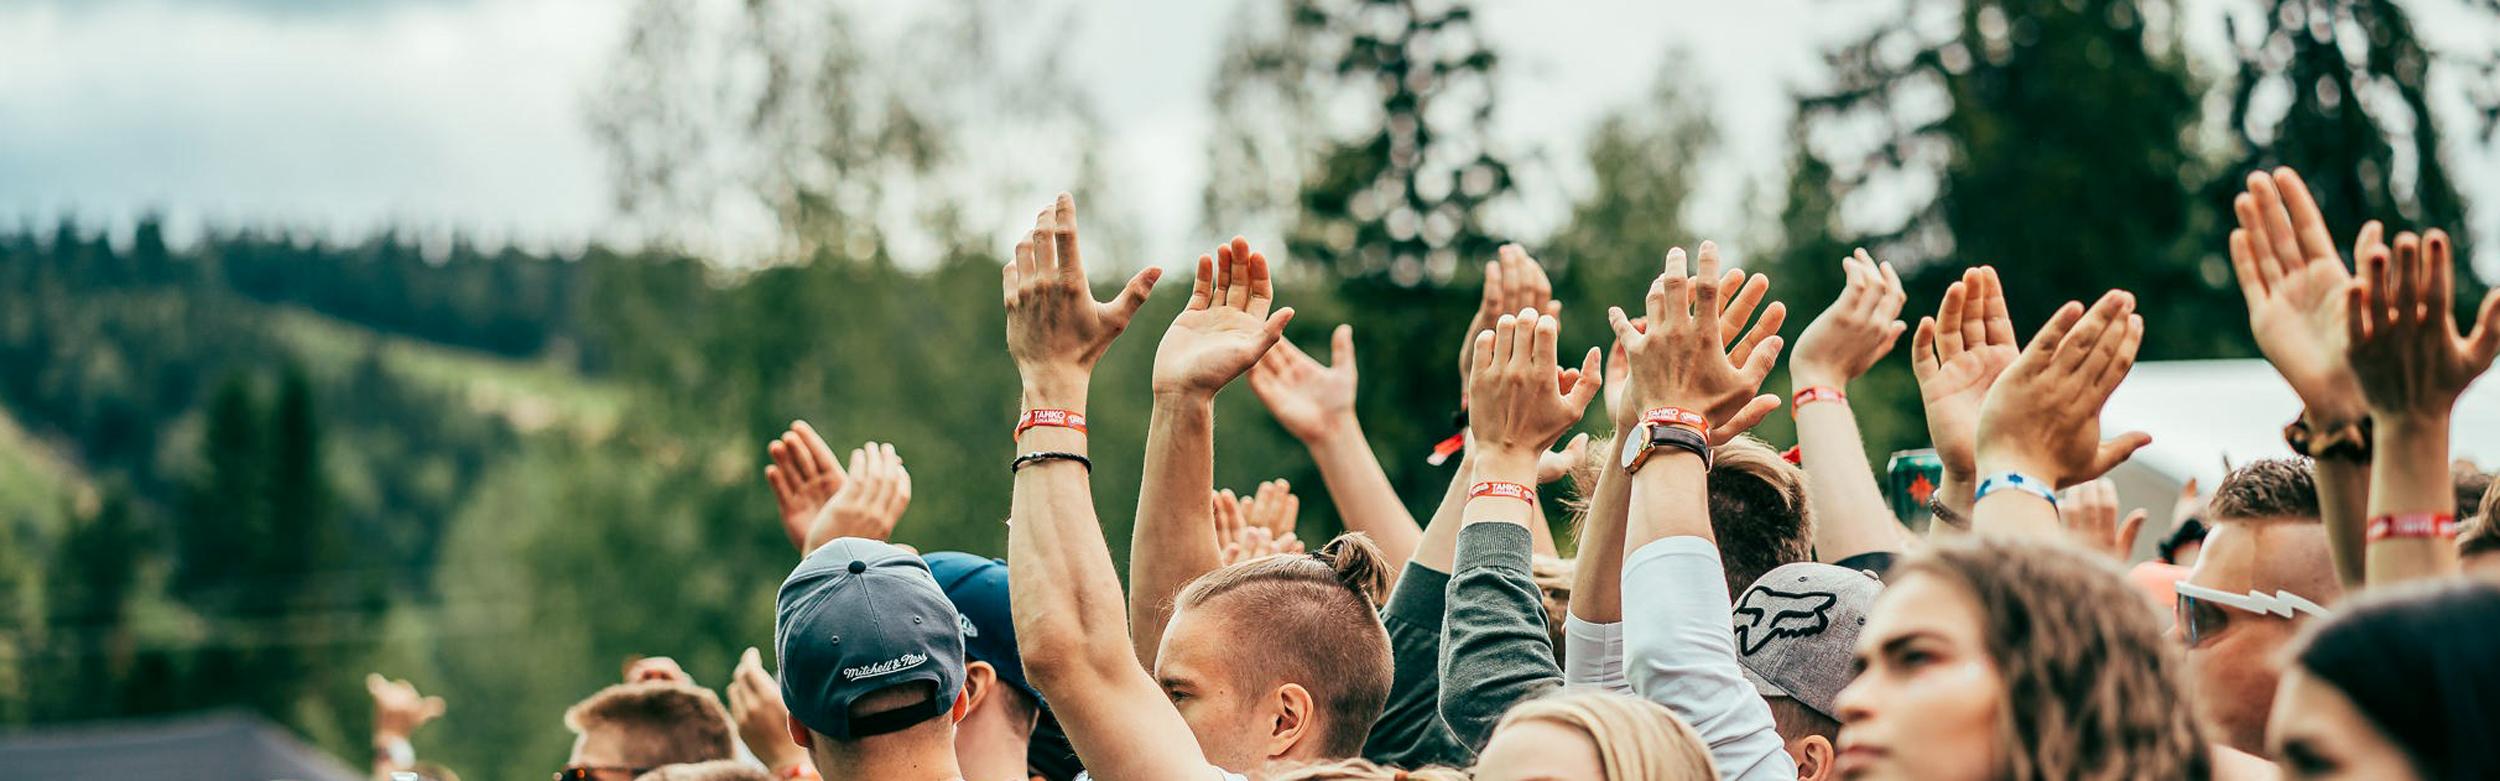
[2230, 168, 2388, 591]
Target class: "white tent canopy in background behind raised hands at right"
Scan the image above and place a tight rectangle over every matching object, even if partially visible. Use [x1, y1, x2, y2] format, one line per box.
[2100, 358, 2500, 555]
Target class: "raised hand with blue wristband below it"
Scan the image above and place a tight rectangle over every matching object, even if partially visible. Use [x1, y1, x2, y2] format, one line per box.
[1978, 290, 2153, 488]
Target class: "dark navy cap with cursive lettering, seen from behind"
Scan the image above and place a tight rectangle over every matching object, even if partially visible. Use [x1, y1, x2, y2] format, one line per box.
[773, 538, 963, 741]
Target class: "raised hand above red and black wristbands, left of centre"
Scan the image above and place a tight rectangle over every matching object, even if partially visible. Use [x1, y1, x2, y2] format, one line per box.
[1000, 193, 1160, 396]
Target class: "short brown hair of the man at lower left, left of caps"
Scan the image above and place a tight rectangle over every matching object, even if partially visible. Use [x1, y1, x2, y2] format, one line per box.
[565, 681, 738, 768]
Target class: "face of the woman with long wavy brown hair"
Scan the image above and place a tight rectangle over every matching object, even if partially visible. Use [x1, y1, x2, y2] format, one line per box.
[1833, 573, 2008, 781]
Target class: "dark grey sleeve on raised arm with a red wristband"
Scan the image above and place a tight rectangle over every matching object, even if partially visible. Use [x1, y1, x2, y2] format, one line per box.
[1440, 523, 1563, 751]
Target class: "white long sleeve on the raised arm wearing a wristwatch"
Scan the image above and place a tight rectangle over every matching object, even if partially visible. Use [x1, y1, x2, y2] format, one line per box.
[1623, 536, 1798, 781]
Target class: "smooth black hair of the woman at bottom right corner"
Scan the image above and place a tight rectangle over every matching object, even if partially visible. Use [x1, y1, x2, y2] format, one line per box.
[2293, 581, 2500, 781]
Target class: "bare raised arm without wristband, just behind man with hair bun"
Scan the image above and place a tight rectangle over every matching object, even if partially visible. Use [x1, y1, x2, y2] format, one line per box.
[1128, 235, 1293, 666]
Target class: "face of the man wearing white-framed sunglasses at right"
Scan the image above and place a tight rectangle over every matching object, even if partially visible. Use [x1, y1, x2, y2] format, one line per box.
[2170, 523, 2323, 756]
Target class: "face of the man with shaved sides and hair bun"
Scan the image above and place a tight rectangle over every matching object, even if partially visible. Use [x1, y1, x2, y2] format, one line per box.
[1155, 606, 1275, 773]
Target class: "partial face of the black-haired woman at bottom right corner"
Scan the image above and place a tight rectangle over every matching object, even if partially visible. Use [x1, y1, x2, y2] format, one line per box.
[2268, 668, 2420, 781]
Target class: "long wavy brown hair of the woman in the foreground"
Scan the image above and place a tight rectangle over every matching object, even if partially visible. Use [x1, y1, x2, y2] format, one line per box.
[1890, 536, 2213, 781]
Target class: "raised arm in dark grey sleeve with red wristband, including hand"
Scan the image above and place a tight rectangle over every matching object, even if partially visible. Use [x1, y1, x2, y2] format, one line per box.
[1440, 308, 1600, 748]
